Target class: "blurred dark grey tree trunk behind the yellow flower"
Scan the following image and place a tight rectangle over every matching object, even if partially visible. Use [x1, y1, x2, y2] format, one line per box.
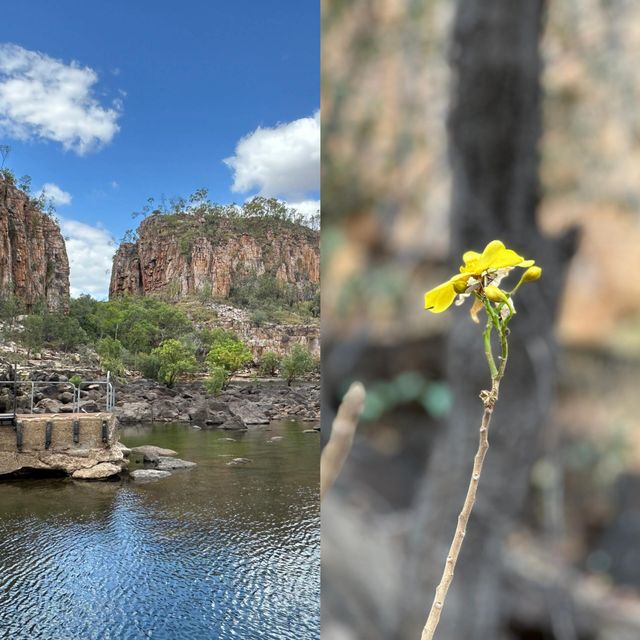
[398, 0, 575, 640]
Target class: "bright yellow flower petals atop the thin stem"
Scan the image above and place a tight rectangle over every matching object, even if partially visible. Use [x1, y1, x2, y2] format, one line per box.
[424, 240, 534, 313]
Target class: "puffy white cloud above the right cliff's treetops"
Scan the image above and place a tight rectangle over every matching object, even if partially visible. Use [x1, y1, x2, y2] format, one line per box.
[224, 111, 320, 199]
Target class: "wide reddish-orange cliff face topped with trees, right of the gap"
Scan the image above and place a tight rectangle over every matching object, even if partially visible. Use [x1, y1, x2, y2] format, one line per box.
[109, 215, 320, 298]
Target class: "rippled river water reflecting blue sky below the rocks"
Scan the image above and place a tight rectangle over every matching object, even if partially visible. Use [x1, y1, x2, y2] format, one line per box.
[0, 422, 320, 640]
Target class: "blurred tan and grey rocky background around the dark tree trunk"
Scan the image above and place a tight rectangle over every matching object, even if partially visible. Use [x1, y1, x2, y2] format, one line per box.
[322, 0, 640, 640]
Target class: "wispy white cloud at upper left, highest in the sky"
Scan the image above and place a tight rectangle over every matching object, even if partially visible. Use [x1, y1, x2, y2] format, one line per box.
[0, 44, 122, 155]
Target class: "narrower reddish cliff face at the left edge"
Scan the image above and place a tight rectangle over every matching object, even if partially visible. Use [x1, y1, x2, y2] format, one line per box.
[0, 177, 69, 311]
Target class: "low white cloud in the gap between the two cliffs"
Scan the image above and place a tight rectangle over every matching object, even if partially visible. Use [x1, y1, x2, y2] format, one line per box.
[60, 218, 115, 299]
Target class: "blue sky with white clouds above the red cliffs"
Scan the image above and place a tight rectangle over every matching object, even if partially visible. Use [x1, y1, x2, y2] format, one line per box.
[0, 0, 320, 297]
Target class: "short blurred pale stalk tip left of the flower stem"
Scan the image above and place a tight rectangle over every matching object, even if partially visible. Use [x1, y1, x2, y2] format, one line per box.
[320, 382, 366, 499]
